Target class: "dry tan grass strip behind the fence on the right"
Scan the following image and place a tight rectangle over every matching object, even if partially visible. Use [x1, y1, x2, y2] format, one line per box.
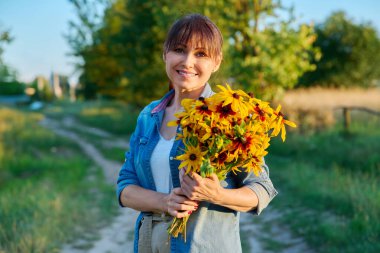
[278, 88, 380, 132]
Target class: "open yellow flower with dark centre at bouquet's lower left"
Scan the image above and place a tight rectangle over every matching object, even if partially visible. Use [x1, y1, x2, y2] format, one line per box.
[176, 145, 207, 173]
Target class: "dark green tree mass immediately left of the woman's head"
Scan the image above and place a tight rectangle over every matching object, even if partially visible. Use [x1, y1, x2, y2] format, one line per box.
[68, 0, 186, 106]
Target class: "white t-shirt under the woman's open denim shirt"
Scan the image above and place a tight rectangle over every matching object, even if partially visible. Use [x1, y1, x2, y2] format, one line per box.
[150, 134, 174, 193]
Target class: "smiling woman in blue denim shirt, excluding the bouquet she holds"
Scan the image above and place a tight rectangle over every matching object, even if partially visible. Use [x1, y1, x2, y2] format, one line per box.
[117, 14, 277, 253]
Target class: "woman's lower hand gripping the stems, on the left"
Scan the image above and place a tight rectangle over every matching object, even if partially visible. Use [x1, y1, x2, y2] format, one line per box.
[166, 188, 198, 218]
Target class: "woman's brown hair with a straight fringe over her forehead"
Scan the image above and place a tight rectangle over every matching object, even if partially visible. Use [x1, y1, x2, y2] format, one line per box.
[164, 14, 223, 59]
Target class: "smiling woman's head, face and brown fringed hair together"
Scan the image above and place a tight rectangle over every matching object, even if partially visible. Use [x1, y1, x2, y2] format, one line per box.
[164, 16, 223, 96]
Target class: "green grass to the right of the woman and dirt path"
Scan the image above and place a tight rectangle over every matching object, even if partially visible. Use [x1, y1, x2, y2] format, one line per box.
[266, 114, 380, 252]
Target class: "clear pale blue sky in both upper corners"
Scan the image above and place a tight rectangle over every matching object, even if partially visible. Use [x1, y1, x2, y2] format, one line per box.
[0, 0, 380, 84]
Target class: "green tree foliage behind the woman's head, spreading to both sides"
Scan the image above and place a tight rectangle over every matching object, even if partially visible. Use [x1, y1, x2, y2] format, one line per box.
[68, 0, 318, 106]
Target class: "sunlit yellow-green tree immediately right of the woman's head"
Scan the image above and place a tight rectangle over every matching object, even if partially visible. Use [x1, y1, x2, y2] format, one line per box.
[218, 0, 319, 99]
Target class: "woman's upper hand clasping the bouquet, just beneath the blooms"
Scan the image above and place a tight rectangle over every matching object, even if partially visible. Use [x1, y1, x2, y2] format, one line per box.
[180, 170, 223, 203]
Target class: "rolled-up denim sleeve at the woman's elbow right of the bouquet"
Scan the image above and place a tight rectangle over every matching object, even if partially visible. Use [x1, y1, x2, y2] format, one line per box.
[237, 161, 277, 215]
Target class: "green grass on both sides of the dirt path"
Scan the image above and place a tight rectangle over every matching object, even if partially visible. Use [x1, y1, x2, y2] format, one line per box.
[0, 96, 380, 252]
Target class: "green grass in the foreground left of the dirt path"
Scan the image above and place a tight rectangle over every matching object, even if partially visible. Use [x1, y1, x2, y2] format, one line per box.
[0, 108, 117, 252]
